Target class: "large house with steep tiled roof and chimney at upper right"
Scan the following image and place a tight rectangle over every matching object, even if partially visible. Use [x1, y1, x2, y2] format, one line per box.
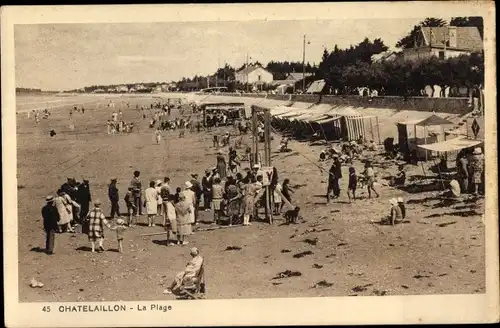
[403, 26, 483, 61]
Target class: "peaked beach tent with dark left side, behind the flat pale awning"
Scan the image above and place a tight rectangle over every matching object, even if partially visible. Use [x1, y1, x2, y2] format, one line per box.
[397, 114, 454, 159]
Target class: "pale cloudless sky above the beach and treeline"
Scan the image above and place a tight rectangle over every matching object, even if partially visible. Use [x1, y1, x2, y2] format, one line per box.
[14, 18, 444, 91]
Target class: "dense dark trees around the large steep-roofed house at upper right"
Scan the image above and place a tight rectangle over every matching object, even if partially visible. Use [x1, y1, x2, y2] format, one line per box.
[316, 17, 484, 96]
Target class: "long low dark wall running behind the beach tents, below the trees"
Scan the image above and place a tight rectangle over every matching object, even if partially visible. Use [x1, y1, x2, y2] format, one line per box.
[216, 93, 471, 115]
